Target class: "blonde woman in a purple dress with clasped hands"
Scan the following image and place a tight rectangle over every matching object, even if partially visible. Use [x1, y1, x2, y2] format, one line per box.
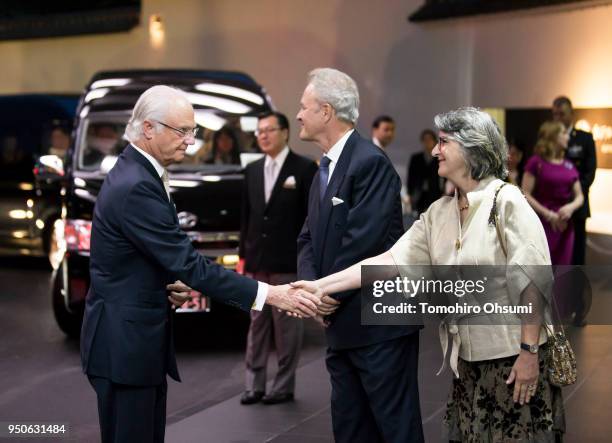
[522, 122, 584, 265]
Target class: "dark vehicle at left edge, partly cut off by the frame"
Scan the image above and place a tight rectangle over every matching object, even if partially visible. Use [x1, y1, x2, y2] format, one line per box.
[0, 94, 79, 264]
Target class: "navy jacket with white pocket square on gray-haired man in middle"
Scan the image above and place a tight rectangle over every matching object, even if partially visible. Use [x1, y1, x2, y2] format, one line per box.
[298, 131, 417, 349]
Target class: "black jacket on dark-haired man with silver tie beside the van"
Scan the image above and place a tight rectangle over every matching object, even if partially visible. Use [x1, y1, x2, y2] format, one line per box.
[240, 151, 317, 274]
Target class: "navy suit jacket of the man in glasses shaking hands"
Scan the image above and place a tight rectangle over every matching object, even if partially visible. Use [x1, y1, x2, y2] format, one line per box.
[81, 146, 257, 386]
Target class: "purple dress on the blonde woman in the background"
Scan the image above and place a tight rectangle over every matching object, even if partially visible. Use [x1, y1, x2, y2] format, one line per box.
[525, 155, 578, 265]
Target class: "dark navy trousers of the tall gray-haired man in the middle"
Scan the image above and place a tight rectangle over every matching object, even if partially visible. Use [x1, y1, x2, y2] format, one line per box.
[326, 332, 424, 443]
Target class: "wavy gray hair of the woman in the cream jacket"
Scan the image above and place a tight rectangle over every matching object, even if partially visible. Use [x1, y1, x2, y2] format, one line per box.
[434, 107, 508, 180]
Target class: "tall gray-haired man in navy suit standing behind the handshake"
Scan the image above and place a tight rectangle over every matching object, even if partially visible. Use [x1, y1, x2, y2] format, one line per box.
[297, 68, 423, 443]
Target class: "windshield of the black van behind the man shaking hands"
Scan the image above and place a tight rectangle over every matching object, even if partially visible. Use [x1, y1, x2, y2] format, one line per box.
[74, 112, 261, 173]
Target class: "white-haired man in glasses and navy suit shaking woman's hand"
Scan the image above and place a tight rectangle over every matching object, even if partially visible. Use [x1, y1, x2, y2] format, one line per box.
[81, 85, 316, 443]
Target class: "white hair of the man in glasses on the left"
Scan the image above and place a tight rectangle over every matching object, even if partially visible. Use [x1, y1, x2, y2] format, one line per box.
[125, 85, 191, 143]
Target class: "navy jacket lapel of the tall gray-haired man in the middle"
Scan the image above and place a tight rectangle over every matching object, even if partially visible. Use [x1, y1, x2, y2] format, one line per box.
[316, 131, 360, 263]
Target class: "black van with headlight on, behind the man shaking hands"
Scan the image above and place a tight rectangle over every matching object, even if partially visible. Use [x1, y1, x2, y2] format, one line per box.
[52, 70, 272, 336]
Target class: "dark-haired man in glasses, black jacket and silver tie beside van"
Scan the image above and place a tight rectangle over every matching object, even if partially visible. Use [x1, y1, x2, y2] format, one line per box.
[240, 112, 317, 404]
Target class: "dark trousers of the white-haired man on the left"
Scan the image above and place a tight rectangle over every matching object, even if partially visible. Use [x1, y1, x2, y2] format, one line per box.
[89, 376, 168, 443]
